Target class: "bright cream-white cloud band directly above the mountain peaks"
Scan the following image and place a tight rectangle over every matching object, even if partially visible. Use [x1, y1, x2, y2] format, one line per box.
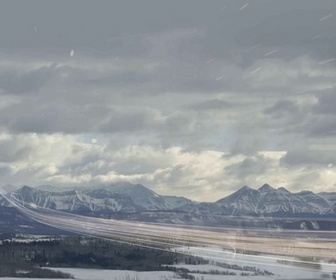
[0, 134, 336, 201]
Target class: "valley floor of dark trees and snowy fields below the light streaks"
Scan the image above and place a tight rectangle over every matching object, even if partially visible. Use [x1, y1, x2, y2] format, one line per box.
[0, 237, 336, 280]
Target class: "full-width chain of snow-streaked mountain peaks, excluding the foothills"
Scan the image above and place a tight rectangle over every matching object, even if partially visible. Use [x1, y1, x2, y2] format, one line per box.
[0, 182, 336, 217]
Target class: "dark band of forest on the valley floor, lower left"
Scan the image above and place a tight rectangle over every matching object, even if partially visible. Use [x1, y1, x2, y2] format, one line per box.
[0, 237, 203, 271]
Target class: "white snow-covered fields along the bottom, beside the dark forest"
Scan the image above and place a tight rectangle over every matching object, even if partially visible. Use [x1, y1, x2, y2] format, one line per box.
[1, 247, 336, 280]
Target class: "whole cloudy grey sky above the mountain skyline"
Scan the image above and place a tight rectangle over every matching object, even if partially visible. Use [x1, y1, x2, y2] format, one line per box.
[0, 0, 336, 201]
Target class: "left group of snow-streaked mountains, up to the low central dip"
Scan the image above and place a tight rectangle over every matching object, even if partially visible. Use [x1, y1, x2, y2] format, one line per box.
[0, 182, 192, 213]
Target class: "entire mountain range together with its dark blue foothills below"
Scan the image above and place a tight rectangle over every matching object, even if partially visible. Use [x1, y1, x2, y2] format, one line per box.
[0, 182, 336, 233]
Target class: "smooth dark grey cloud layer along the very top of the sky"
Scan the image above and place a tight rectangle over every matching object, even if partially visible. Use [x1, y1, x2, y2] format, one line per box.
[0, 0, 336, 62]
